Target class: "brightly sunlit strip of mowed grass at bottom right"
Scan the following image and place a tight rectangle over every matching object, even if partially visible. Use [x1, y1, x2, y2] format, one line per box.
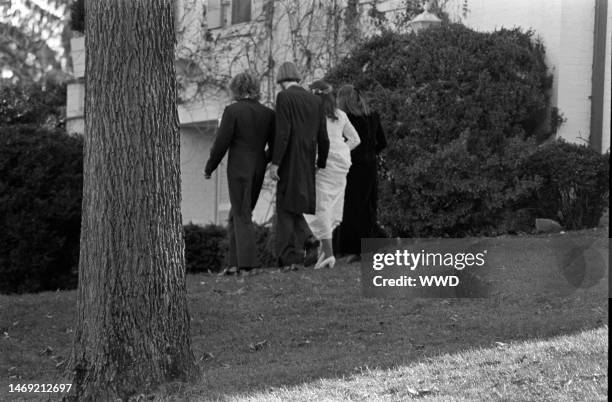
[230, 327, 608, 402]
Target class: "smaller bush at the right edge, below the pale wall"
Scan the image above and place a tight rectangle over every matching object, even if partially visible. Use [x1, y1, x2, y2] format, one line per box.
[520, 140, 610, 230]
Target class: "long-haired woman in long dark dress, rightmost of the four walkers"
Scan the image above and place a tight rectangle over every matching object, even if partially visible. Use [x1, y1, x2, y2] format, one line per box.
[334, 85, 387, 262]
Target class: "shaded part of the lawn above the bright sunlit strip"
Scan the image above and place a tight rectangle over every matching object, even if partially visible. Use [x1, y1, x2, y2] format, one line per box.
[0, 230, 609, 400]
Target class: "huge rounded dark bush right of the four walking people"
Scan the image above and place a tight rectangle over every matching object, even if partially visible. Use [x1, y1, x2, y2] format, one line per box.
[327, 24, 558, 236]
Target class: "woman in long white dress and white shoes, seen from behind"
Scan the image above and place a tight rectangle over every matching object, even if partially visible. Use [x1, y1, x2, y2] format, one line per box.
[304, 81, 360, 269]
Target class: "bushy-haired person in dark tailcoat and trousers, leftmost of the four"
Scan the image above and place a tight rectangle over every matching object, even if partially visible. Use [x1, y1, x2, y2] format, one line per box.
[204, 72, 274, 272]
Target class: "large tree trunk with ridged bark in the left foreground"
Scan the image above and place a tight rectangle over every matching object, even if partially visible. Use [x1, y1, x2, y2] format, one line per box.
[71, 0, 196, 400]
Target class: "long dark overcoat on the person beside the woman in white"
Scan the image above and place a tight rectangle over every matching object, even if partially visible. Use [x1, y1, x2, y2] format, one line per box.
[272, 85, 329, 214]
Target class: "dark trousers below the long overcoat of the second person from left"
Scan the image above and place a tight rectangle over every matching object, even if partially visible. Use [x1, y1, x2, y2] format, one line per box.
[276, 203, 312, 267]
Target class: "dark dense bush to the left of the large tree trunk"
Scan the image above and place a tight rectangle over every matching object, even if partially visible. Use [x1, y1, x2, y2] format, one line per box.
[0, 125, 83, 293]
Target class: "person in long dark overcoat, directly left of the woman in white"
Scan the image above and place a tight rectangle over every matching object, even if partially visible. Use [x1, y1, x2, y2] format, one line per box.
[270, 62, 329, 267]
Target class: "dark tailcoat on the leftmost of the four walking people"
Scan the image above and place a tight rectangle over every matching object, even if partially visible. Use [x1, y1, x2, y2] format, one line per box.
[204, 99, 274, 215]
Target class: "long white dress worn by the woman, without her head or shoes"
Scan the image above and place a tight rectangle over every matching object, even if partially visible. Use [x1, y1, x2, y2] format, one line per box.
[304, 109, 361, 239]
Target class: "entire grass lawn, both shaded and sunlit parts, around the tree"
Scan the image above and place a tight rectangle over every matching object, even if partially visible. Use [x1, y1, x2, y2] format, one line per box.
[0, 229, 609, 401]
